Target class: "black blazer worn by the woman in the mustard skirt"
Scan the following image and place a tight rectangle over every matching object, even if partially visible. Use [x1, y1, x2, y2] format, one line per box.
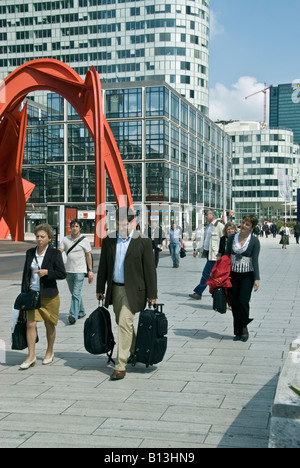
[22, 245, 67, 297]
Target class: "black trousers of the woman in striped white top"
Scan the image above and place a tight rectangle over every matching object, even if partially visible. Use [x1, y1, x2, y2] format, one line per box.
[228, 271, 254, 336]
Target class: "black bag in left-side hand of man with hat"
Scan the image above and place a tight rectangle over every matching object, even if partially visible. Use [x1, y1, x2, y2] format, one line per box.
[83, 304, 116, 363]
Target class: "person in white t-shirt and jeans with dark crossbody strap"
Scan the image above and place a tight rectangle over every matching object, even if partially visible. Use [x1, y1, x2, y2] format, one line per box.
[60, 219, 94, 325]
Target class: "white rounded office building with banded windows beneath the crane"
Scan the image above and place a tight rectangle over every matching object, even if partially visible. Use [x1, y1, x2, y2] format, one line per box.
[222, 122, 300, 223]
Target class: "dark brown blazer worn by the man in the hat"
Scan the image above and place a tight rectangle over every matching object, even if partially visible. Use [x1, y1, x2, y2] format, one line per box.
[96, 231, 157, 313]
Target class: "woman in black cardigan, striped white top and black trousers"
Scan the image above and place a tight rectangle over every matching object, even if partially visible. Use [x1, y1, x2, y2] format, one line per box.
[226, 214, 260, 342]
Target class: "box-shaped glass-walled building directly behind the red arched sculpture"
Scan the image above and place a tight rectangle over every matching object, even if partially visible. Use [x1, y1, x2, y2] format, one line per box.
[23, 82, 232, 232]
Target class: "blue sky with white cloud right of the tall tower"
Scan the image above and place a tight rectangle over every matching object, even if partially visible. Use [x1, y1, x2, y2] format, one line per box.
[209, 0, 300, 122]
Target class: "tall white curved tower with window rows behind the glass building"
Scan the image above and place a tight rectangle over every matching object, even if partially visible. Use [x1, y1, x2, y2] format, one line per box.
[0, 0, 210, 115]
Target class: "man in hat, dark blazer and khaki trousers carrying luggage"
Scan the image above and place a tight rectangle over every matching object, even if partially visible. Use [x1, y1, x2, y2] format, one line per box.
[96, 208, 157, 380]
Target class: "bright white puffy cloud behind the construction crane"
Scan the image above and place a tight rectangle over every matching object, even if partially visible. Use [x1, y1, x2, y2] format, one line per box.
[209, 76, 269, 122]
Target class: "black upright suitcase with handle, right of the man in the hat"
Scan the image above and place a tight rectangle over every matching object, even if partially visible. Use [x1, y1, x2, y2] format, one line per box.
[132, 304, 168, 367]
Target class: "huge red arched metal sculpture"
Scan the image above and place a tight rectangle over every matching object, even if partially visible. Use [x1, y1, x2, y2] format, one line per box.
[0, 59, 132, 247]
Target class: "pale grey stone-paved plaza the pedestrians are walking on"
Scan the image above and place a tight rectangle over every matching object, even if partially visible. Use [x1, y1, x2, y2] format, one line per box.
[0, 237, 300, 452]
